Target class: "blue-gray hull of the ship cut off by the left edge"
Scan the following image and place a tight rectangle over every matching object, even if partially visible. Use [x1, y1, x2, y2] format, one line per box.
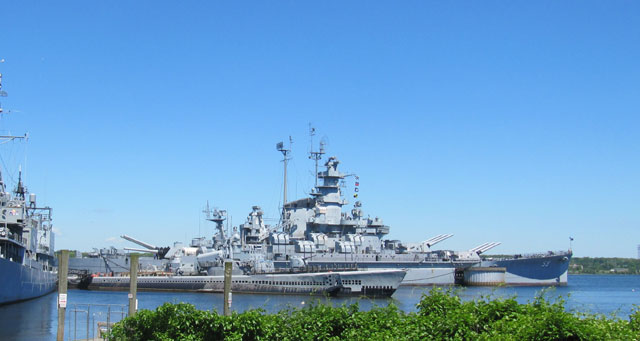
[0, 258, 57, 304]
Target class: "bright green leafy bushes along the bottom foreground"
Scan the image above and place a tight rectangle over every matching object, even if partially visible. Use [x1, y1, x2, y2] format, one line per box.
[109, 288, 640, 340]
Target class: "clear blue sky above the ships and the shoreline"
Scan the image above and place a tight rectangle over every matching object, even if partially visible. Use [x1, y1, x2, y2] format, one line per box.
[0, 1, 640, 257]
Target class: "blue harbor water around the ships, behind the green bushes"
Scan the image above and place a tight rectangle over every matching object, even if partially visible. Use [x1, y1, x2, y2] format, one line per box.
[0, 275, 640, 340]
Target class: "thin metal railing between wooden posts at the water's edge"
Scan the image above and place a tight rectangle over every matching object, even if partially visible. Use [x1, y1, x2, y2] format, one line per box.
[65, 304, 128, 341]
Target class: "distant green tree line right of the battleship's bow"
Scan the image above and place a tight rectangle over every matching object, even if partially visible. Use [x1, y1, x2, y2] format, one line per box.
[569, 257, 640, 275]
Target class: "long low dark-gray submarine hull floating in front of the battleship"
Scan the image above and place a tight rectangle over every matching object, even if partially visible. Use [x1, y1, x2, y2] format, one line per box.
[78, 270, 405, 297]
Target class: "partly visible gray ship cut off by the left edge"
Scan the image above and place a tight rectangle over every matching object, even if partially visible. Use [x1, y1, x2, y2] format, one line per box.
[0, 71, 57, 304]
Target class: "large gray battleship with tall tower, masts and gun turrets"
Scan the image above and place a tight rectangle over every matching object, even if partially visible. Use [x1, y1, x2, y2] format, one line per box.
[220, 133, 572, 286]
